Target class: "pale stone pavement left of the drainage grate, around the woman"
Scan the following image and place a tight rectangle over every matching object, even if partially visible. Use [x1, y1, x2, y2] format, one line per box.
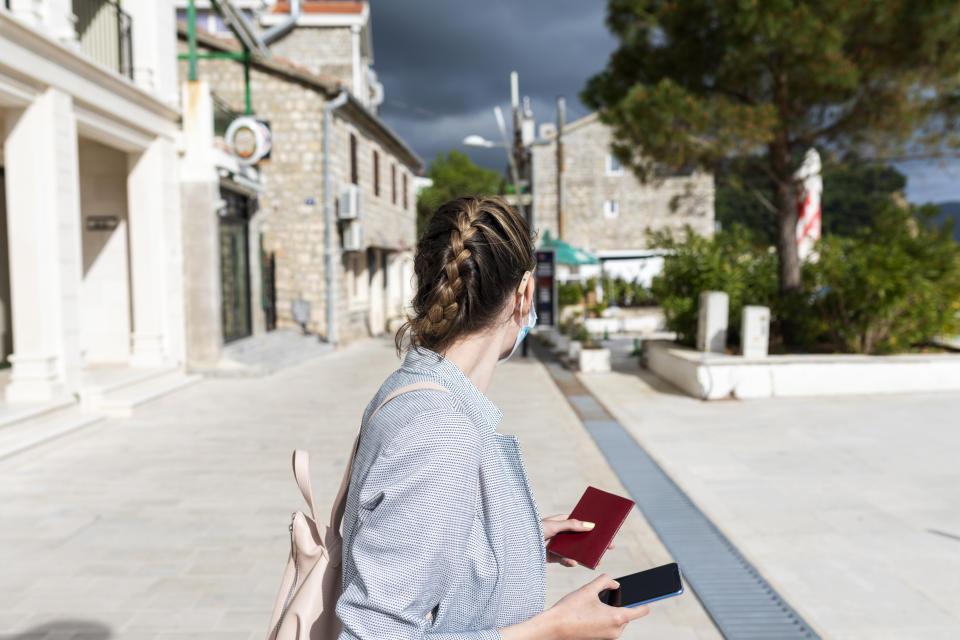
[0, 339, 720, 640]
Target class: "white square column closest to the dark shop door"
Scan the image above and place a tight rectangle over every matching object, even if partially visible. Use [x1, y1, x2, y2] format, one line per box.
[127, 138, 172, 367]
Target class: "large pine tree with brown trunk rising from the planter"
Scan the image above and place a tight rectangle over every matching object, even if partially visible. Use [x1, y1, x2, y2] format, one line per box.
[581, 0, 960, 291]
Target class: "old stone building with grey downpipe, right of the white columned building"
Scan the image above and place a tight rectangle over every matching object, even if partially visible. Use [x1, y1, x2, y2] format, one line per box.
[178, 2, 421, 364]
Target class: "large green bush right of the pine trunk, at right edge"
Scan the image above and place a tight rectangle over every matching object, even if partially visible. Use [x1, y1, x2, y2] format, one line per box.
[804, 204, 960, 353]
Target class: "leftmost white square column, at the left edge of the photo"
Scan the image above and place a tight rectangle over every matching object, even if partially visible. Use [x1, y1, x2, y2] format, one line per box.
[4, 89, 82, 402]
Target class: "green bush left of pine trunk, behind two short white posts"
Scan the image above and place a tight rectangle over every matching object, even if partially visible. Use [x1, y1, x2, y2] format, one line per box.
[650, 225, 777, 346]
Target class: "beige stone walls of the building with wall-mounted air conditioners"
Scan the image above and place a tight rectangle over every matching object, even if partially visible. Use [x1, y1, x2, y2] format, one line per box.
[181, 42, 416, 343]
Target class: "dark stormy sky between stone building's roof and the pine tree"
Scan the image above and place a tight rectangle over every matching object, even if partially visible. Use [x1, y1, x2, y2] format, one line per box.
[370, 0, 616, 170]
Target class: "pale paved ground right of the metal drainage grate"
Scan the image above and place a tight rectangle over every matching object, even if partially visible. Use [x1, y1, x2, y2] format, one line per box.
[579, 340, 960, 640]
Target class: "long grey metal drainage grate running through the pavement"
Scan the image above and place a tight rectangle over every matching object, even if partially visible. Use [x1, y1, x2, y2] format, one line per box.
[537, 349, 820, 640]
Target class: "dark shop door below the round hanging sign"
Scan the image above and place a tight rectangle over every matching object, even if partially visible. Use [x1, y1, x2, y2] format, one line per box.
[220, 189, 251, 342]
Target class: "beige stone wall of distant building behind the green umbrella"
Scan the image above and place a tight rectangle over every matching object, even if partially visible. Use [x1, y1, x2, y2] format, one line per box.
[533, 120, 714, 251]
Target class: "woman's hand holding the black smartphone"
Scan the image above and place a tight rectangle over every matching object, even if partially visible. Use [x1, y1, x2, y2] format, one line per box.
[544, 573, 650, 640]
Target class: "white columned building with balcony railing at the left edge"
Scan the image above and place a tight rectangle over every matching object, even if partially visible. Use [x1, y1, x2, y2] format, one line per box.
[0, 0, 195, 410]
